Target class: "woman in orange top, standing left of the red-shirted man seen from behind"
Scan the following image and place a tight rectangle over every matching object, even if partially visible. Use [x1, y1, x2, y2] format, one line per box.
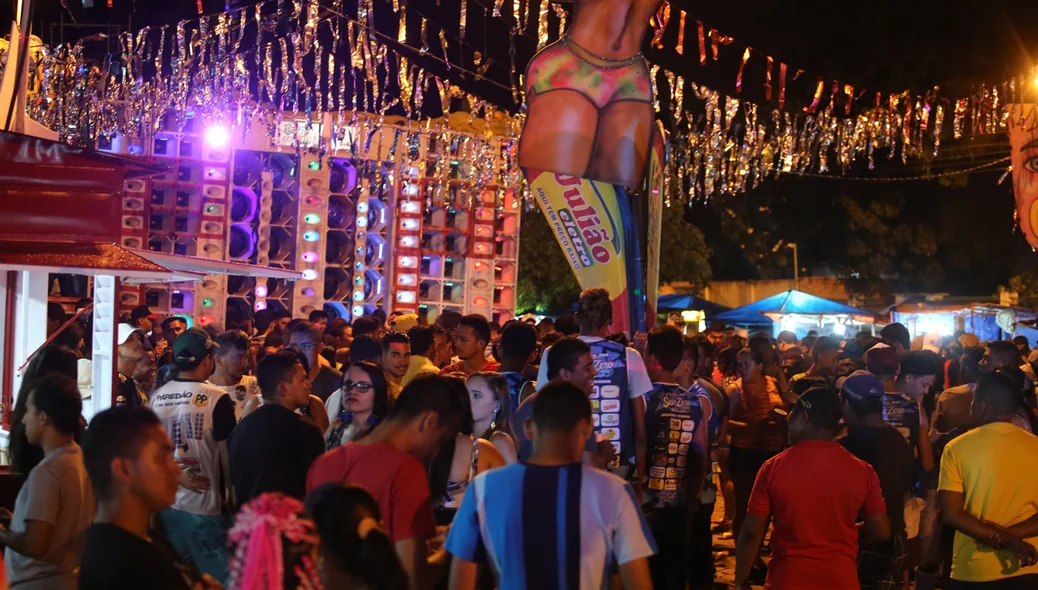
[728, 348, 786, 548]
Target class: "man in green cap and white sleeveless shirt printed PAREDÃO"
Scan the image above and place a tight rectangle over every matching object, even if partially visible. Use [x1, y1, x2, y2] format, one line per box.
[152, 328, 237, 582]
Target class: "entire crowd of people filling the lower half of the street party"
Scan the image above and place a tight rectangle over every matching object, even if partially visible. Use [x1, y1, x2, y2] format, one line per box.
[8, 289, 1038, 590]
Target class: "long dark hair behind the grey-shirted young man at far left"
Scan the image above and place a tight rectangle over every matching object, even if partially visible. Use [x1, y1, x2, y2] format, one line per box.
[7, 344, 79, 475]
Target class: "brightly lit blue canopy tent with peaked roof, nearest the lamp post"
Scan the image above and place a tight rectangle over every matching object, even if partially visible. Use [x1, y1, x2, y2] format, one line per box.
[710, 290, 876, 333]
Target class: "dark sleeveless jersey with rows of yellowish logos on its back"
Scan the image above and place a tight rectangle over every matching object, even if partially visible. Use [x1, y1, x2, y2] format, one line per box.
[643, 383, 703, 507]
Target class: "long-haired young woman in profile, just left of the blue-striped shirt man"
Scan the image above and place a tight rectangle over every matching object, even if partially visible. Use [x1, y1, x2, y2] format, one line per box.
[465, 371, 519, 464]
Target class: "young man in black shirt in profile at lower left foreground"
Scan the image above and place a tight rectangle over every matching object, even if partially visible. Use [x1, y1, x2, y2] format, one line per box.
[79, 407, 222, 590]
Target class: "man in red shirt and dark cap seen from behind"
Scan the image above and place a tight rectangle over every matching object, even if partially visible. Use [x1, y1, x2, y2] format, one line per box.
[735, 386, 891, 590]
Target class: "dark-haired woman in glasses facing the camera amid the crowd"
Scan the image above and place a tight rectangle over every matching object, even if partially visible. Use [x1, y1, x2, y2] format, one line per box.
[325, 361, 389, 451]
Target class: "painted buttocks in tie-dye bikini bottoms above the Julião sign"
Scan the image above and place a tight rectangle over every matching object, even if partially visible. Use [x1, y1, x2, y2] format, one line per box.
[519, 0, 661, 188]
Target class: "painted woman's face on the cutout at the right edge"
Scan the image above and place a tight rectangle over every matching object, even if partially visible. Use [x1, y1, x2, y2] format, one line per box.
[1009, 105, 1038, 248]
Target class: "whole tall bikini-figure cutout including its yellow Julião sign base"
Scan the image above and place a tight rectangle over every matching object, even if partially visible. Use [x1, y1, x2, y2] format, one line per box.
[519, 0, 665, 332]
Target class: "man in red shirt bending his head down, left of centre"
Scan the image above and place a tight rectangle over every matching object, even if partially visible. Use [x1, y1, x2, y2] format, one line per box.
[306, 375, 467, 590]
